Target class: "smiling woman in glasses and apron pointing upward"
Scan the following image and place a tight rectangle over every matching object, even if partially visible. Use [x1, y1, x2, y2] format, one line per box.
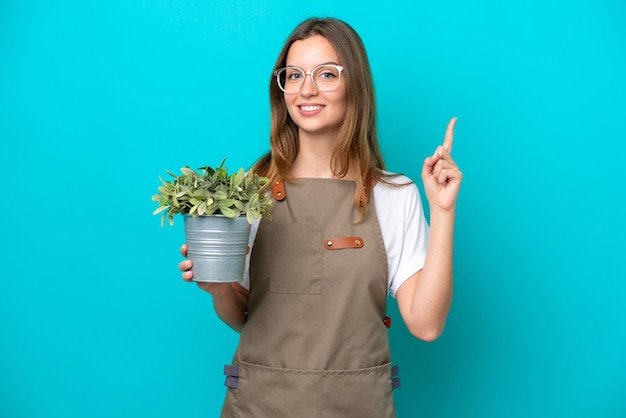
[179, 19, 462, 418]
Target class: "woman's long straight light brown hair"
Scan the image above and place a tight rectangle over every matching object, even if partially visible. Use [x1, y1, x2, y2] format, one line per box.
[254, 18, 386, 222]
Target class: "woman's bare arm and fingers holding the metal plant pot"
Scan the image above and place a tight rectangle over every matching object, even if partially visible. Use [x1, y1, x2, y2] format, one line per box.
[178, 245, 248, 332]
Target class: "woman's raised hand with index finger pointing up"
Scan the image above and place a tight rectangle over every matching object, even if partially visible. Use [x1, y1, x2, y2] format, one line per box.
[422, 118, 463, 212]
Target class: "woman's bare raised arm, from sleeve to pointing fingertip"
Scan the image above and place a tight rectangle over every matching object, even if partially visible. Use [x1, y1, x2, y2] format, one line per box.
[396, 118, 463, 341]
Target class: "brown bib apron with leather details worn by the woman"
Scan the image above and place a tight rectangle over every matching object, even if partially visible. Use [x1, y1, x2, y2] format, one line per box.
[221, 179, 399, 418]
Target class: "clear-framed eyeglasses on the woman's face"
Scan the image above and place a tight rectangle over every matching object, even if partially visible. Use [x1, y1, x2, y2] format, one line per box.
[274, 64, 343, 93]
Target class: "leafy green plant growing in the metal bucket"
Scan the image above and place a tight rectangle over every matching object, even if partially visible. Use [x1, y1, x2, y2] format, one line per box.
[152, 159, 272, 226]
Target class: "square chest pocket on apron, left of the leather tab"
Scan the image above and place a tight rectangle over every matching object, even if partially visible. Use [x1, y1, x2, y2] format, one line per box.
[269, 222, 322, 295]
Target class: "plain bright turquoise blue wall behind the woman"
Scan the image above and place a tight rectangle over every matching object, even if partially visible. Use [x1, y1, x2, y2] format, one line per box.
[0, 0, 626, 418]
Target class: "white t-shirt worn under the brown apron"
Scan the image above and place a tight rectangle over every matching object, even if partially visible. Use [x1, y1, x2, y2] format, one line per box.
[240, 176, 430, 297]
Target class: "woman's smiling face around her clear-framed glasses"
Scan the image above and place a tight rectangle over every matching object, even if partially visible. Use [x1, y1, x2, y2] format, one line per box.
[284, 35, 348, 137]
